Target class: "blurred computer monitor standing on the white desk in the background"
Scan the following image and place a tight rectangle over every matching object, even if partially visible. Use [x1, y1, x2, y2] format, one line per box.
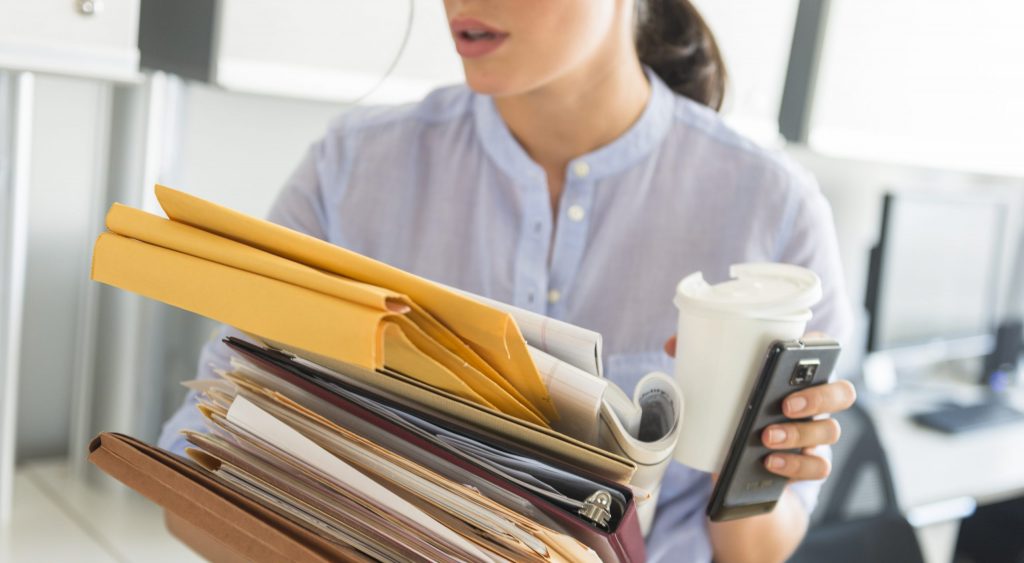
[866, 191, 1009, 359]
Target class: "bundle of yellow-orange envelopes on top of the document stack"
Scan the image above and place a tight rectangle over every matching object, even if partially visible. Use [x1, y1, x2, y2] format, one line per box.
[92, 186, 556, 426]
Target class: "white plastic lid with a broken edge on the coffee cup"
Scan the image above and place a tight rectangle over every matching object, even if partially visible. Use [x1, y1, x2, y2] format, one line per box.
[676, 262, 821, 320]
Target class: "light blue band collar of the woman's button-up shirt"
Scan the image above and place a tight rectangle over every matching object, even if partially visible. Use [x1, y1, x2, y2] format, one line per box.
[473, 67, 675, 182]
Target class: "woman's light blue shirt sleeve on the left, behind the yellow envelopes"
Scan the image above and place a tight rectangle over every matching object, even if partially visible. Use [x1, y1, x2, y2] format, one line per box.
[157, 143, 326, 454]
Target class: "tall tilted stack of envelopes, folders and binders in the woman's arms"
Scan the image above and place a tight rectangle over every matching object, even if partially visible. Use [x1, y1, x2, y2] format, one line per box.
[90, 186, 681, 561]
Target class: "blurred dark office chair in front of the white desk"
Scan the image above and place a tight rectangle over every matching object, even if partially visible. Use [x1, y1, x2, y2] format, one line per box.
[790, 405, 924, 563]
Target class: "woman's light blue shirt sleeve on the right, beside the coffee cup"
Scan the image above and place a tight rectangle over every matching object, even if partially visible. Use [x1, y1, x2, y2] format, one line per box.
[777, 163, 853, 514]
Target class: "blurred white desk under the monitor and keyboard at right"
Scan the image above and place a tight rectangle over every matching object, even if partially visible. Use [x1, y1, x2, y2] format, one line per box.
[863, 381, 1024, 563]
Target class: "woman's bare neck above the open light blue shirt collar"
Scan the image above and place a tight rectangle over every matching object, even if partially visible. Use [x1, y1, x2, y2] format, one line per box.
[495, 44, 650, 208]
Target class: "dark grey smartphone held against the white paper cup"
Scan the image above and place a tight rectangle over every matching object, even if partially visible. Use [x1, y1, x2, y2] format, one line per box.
[708, 340, 840, 522]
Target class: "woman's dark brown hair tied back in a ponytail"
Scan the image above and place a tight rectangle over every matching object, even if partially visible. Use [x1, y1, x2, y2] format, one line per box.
[636, 0, 726, 111]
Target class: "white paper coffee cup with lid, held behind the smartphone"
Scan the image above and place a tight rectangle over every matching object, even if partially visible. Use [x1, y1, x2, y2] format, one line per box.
[675, 263, 821, 472]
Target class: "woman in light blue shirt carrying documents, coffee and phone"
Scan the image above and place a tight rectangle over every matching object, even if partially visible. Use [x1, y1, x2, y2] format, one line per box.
[161, 0, 853, 562]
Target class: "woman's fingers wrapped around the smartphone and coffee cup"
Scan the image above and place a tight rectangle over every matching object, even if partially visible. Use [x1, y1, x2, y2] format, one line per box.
[665, 335, 857, 481]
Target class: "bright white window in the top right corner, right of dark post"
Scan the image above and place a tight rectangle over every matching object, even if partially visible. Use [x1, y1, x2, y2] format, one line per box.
[809, 0, 1024, 175]
